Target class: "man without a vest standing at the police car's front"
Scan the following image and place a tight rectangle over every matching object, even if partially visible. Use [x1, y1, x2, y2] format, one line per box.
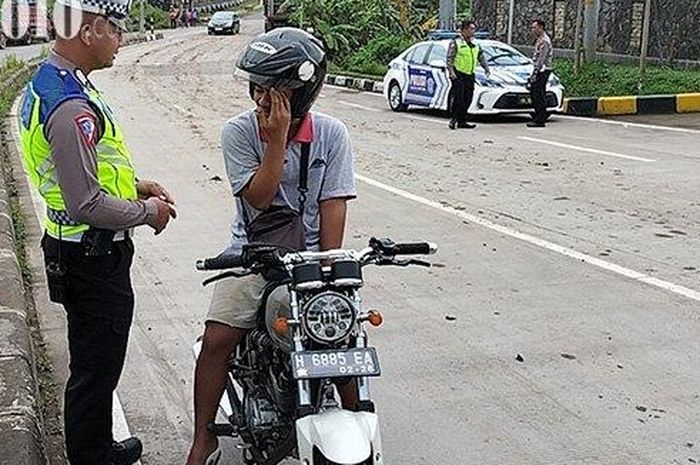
[527, 19, 553, 128]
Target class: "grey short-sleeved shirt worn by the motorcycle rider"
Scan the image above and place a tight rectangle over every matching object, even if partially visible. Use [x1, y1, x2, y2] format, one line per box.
[221, 110, 357, 253]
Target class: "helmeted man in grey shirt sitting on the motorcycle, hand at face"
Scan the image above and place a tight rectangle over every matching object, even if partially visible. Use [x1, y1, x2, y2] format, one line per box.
[187, 28, 356, 465]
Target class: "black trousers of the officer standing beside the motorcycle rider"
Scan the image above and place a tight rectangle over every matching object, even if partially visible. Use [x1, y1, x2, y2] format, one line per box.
[42, 235, 134, 465]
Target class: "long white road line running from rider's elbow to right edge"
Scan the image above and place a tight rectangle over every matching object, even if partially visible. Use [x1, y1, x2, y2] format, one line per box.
[355, 174, 700, 302]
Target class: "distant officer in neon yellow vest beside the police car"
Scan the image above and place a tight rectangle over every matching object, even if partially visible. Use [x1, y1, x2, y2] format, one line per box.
[447, 19, 491, 129]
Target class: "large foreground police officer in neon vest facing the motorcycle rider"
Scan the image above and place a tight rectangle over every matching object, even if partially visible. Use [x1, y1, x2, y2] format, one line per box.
[20, 0, 176, 465]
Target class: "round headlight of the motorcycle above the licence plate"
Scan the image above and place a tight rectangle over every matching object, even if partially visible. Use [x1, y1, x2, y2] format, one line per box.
[303, 292, 357, 344]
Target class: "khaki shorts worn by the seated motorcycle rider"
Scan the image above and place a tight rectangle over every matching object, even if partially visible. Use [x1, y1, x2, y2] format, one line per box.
[206, 275, 265, 329]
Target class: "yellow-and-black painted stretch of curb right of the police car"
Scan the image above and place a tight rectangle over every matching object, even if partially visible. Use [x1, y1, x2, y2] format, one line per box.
[564, 93, 700, 116]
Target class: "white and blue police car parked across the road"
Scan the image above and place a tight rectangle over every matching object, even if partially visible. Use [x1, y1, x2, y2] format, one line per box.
[384, 39, 564, 115]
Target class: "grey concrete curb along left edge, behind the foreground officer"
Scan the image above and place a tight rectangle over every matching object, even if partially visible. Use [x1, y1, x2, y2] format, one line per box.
[0, 66, 46, 465]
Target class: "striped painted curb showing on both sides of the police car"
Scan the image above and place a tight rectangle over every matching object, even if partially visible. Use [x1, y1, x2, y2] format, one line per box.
[326, 74, 700, 116]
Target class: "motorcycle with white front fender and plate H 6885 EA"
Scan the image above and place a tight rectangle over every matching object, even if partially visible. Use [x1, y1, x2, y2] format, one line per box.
[194, 238, 437, 465]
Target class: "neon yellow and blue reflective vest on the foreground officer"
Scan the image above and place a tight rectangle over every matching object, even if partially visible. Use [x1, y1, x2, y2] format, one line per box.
[20, 63, 138, 237]
